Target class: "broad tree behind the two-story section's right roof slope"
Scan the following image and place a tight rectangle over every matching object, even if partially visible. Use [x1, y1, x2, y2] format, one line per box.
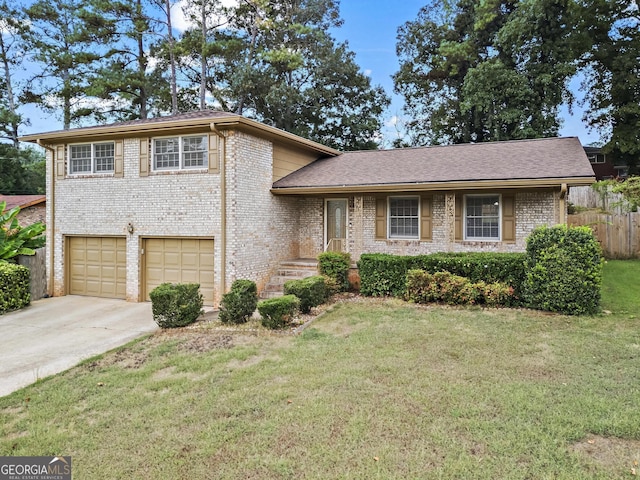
[179, 0, 389, 149]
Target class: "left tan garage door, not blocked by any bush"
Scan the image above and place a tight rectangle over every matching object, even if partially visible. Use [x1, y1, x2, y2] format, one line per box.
[67, 237, 127, 298]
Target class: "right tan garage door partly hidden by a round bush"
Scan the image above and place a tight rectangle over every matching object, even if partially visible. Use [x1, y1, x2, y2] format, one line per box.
[144, 238, 214, 305]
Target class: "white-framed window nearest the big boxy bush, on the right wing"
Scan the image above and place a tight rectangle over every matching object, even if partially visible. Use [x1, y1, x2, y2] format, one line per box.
[464, 195, 500, 240]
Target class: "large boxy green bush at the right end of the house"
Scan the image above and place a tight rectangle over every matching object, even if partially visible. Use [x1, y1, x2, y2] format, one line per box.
[524, 225, 603, 315]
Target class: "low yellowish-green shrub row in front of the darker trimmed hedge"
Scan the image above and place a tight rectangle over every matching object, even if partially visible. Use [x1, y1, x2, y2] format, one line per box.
[407, 270, 513, 307]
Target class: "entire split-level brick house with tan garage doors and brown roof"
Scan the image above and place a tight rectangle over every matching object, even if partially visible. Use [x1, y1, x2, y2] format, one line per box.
[23, 111, 593, 305]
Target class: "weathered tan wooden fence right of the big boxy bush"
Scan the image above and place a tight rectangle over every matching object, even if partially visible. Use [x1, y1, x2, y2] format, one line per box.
[568, 212, 640, 258]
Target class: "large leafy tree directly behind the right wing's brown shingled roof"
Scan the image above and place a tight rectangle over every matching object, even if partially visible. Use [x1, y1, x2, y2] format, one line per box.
[394, 0, 576, 144]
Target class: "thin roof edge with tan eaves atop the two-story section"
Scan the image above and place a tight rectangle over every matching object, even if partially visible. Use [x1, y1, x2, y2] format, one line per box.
[20, 110, 340, 155]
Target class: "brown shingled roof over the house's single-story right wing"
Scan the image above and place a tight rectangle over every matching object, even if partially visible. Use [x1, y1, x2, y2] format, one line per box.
[272, 137, 594, 194]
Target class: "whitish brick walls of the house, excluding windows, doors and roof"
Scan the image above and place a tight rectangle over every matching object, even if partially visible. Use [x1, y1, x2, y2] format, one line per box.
[46, 120, 564, 305]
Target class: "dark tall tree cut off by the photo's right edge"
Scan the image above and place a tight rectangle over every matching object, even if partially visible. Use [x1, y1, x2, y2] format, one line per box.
[579, 0, 640, 174]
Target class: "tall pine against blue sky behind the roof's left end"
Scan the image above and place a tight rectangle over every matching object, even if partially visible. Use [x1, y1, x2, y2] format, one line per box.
[25, 0, 106, 129]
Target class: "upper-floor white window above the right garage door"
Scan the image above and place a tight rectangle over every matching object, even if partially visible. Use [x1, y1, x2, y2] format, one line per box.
[153, 135, 208, 170]
